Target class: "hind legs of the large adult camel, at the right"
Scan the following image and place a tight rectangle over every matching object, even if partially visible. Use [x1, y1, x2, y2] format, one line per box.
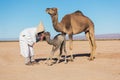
[85, 30, 96, 60]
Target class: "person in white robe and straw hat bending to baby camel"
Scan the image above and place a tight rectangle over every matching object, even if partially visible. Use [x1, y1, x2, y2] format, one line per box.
[19, 23, 44, 65]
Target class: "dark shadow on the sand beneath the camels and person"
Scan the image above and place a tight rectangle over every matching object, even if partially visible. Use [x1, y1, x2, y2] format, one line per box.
[35, 53, 90, 63]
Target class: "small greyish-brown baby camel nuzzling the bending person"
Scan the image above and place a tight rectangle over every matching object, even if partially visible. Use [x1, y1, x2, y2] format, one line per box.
[44, 32, 67, 65]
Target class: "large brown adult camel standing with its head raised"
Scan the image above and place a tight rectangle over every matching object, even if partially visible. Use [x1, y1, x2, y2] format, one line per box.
[46, 8, 96, 61]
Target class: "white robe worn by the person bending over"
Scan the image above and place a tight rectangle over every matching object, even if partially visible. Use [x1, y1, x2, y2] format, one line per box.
[19, 28, 37, 58]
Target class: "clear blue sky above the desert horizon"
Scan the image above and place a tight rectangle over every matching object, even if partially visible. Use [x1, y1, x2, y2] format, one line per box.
[0, 0, 120, 39]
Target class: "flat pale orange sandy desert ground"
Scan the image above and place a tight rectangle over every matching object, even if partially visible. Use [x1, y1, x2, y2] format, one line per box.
[0, 41, 120, 80]
